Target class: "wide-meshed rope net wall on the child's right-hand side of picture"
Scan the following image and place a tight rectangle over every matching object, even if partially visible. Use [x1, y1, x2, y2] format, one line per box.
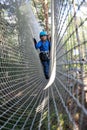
[53, 0, 87, 130]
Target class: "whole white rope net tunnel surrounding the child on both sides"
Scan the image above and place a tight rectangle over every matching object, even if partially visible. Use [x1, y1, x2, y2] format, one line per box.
[0, 0, 87, 130]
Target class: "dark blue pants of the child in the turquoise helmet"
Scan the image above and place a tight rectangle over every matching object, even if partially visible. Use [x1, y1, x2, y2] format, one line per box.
[41, 60, 50, 78]
